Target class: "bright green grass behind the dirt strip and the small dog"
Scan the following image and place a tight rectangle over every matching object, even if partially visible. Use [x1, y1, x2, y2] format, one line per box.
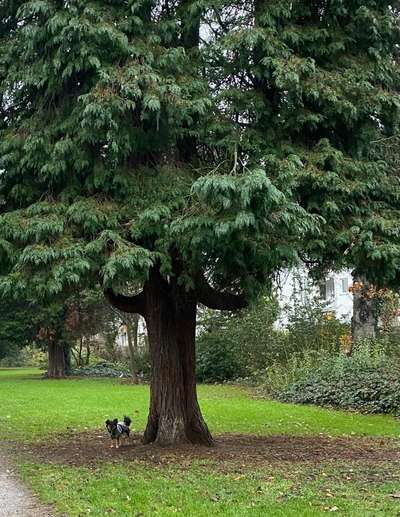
[0, 370, 400, 441]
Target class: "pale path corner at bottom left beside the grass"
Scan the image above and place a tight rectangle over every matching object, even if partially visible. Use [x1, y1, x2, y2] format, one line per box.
[0, 449, 53, 517]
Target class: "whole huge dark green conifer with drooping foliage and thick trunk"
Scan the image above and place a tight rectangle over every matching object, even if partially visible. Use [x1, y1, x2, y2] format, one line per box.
[0, 0, 399, 444]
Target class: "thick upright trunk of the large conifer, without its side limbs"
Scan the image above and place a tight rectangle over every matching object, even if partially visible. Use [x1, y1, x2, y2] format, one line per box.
[144, 275, 213, 445]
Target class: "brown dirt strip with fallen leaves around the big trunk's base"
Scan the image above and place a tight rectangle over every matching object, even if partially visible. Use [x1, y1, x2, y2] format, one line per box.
[13, 431, 400, 467]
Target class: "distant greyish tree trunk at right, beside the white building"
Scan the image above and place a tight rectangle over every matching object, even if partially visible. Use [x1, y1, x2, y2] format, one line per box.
[351, 276, 378, 343]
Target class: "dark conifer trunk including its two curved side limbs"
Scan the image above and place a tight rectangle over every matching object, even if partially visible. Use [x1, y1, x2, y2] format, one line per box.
[104, 268, 247, 445]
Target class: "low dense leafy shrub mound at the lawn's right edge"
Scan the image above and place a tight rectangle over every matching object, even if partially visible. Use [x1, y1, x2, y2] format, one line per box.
[274, 344, 400, 414]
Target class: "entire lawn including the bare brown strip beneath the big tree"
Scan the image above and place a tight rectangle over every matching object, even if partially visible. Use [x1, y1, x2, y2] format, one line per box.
[0, 369, 400, 517]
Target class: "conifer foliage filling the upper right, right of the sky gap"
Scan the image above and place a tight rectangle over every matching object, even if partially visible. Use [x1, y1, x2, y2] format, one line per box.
[205, 0, 400, 283]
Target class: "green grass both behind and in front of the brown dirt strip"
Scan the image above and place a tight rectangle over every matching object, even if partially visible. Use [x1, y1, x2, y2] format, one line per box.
[0, 369, 400, 517]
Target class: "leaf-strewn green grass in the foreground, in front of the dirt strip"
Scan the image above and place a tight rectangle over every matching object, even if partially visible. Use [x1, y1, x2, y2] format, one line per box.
[23, 464, 400, 517]
